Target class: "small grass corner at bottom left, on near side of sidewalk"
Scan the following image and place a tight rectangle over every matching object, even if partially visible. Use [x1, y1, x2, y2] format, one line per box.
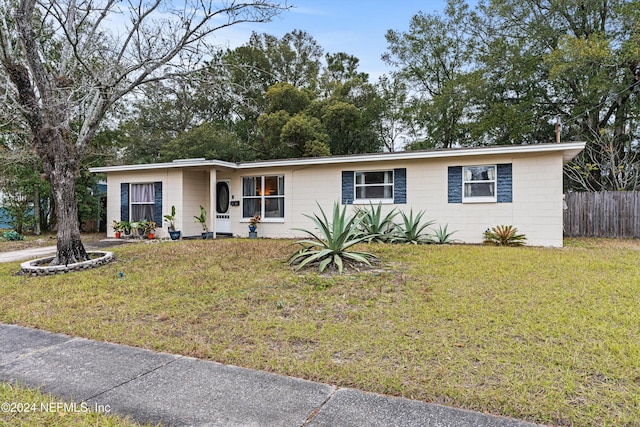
[0, 383, 139, 427]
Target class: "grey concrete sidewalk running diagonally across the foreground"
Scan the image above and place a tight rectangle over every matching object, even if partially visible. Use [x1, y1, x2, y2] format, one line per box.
[0, 324, 534, 427]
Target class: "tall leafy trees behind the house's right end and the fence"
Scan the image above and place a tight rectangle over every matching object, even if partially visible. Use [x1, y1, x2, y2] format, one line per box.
[385, 0, 640, 190]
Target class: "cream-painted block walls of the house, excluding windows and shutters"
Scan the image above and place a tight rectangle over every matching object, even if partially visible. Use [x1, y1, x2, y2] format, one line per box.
[107, 153, 562, 246]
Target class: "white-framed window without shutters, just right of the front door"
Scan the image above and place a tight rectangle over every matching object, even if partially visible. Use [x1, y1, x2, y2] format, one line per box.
[242, 175, 284, 220]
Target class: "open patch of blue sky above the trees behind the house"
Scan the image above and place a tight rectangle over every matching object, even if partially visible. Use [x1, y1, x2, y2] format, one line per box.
[211, 0, 446, 82]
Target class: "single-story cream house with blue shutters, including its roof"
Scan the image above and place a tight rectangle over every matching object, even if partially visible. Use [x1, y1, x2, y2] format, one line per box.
[91, 142, 584, 246]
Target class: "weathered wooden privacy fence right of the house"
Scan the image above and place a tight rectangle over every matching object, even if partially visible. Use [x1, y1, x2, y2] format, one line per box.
[564, 191, 640, 238]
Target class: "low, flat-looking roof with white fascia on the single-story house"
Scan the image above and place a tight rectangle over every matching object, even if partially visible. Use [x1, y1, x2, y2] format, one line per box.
[89, 142, 585, 173]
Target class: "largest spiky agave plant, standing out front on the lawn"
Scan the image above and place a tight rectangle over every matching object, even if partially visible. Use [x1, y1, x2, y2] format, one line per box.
[288, 203, 376, 273]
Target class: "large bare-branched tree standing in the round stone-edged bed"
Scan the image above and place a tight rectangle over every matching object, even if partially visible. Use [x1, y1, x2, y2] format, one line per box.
[0, 0, 287, 264]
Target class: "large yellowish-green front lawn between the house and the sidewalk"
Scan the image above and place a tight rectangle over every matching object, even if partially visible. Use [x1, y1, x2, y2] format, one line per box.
[0, 239, 640, 426]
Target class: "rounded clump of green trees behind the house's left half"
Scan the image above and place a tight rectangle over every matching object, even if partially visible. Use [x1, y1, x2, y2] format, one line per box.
[118, 30, 382, 163]
